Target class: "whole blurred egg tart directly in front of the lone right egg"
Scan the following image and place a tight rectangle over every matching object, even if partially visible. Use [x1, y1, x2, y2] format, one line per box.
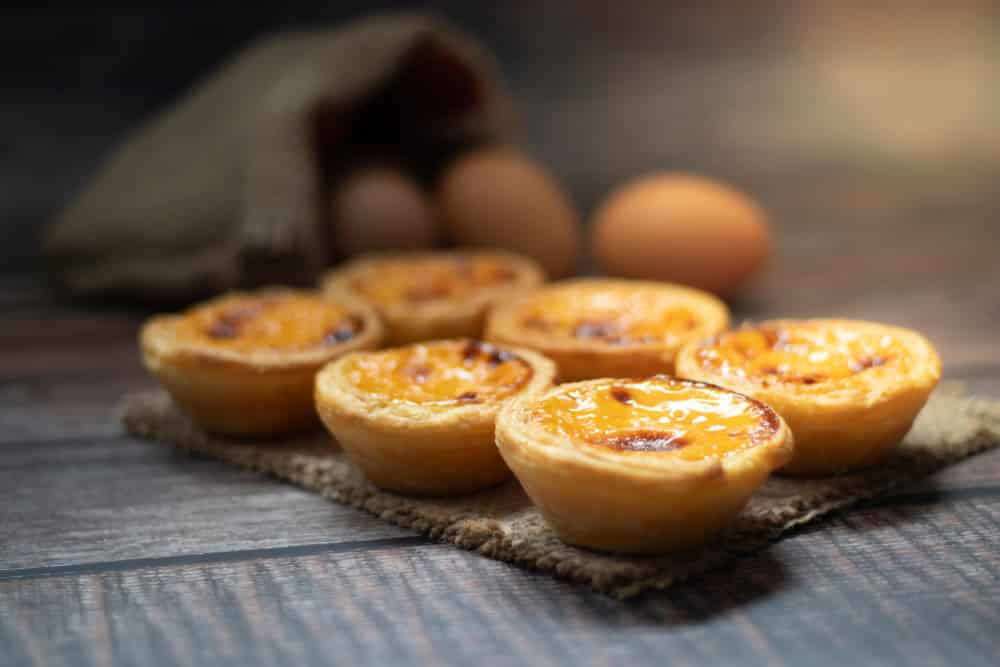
[486, 279, 729, 381]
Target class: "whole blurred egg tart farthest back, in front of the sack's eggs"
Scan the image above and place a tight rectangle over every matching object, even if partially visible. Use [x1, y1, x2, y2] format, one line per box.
[323, 251, 544, 345]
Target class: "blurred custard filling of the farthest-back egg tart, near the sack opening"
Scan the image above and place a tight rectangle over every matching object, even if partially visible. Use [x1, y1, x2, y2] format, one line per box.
[352, 256, 517, 306]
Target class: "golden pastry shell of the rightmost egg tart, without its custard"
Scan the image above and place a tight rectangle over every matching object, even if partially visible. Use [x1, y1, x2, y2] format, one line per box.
[677, 319, 941, 476]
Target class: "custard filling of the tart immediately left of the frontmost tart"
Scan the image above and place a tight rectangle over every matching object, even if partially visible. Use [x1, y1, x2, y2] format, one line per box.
[346, 340, 532, 405]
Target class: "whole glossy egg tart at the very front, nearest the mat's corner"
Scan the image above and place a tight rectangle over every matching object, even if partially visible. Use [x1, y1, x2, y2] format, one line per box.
[496, 375, 793, 553]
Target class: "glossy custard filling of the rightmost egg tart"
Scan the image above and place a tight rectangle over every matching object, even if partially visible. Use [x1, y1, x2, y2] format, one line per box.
[697, 323, 904, 386]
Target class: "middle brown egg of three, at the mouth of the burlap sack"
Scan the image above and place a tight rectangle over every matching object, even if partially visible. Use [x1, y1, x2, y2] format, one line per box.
[437, 148, 580, 277]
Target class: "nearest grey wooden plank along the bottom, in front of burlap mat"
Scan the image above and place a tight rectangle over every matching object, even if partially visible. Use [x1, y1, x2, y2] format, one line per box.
[0, 498, 1000, 665]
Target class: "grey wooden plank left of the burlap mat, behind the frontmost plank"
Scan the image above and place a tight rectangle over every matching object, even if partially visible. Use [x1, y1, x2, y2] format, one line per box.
[0, 438, 412, 570]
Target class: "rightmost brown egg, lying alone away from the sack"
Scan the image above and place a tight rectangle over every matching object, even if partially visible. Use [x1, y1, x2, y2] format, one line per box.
[590, 173, 771, 294]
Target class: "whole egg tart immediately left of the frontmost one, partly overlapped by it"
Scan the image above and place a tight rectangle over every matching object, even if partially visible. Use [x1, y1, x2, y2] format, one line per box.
[316, 339, 555, 495]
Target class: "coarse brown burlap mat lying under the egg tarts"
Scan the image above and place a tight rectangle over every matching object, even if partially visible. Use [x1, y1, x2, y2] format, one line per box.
[122, 387, 1000, 599]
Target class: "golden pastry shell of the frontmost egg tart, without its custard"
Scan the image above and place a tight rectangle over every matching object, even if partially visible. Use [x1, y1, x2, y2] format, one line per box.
[496, 381, 793, 553]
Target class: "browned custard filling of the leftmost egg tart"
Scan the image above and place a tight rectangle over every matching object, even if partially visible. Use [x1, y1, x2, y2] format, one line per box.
[176, 294, 362, 352]
